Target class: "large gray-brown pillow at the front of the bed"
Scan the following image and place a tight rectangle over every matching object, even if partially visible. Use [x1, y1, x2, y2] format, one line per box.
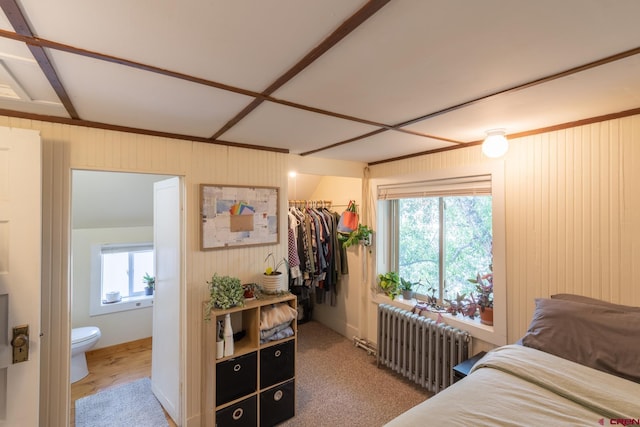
[522, 298, 640, 383]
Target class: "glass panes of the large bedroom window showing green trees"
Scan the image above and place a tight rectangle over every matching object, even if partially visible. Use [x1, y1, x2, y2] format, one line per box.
[391, 195, 493, 301]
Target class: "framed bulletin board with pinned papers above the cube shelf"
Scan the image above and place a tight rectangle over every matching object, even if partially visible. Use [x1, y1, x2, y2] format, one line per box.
[200, 184, 279, 250]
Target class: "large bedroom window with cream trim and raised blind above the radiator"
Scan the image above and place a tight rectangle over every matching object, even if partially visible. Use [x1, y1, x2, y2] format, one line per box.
[374, 162, 506, 345]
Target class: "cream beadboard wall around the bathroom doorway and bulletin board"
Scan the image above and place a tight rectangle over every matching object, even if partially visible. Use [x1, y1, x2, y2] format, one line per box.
[0, 113, 363, 426]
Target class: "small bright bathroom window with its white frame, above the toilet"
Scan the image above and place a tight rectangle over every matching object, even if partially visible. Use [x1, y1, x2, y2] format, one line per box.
[90, 243, 154, 315]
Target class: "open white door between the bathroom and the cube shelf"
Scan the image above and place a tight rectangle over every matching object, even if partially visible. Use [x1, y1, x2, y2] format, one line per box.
[151, 177, 182, 425]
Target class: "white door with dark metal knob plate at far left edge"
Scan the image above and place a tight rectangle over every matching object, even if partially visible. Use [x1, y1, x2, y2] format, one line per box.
[0, 127, 42, 427]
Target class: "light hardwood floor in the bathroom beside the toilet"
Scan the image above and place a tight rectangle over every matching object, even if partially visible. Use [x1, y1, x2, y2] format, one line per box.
[70, 338, 176, 427]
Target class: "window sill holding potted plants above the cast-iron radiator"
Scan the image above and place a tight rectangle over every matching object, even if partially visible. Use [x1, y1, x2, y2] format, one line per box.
[373, 294, 506, 346]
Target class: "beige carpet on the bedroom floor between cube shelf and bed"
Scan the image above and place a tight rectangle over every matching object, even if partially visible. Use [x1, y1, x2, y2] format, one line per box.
[281, 321, 431, 427]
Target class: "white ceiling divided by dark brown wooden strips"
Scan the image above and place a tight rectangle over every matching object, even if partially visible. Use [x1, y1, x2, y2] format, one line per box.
[0, 0, 640, 163]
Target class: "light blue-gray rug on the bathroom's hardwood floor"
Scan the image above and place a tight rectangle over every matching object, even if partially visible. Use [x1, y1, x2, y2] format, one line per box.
[75, 378, 169, 427]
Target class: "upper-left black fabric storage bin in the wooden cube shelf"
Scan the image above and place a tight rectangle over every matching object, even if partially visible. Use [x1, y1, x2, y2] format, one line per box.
[216, 352, 258, 406]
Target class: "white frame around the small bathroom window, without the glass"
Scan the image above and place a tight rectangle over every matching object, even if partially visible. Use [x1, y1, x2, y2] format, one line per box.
[89, 242, 155, 316]
